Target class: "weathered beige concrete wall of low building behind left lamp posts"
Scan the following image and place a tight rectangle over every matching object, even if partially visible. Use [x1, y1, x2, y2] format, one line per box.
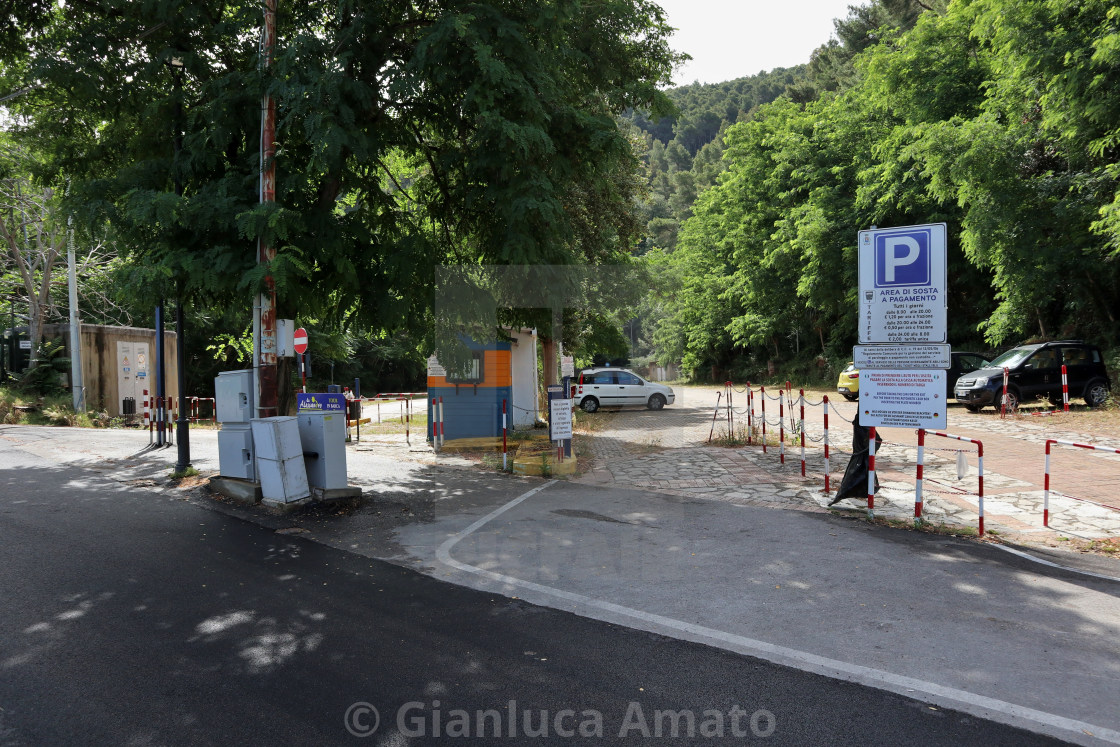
[43, 325, 179, 417]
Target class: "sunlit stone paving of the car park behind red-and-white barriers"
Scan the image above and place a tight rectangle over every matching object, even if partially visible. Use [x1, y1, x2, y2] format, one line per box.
[578, 389, 1120, 540]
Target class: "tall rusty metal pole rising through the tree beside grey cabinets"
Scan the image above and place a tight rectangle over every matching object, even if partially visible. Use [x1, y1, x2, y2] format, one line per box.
[253, 0, 280, 418]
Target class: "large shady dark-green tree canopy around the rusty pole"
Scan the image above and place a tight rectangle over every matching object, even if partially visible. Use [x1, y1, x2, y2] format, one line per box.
[4, 0, 679, 347]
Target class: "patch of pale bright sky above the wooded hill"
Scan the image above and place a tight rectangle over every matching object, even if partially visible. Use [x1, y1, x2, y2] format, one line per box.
[657, 0, 865, 85]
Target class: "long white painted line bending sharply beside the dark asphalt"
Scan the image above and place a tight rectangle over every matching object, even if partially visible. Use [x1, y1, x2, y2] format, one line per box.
[436, 480, 1120, 744]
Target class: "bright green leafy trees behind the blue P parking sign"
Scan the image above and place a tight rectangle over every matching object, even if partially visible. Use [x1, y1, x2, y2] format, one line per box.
[648, 0, 1120, 375]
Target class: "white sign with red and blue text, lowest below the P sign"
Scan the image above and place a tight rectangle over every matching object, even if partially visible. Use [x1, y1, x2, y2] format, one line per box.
[859, 368, 949, 429]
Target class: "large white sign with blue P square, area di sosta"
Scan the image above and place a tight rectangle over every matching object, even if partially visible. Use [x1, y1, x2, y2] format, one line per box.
[859, 223, 948, 344]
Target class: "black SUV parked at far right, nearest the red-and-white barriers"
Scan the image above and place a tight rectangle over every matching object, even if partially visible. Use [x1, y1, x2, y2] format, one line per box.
[953, 339, 1112, 412]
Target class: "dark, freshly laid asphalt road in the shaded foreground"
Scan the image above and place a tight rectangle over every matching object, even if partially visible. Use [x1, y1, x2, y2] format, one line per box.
[0, 443, 1051, 745]
